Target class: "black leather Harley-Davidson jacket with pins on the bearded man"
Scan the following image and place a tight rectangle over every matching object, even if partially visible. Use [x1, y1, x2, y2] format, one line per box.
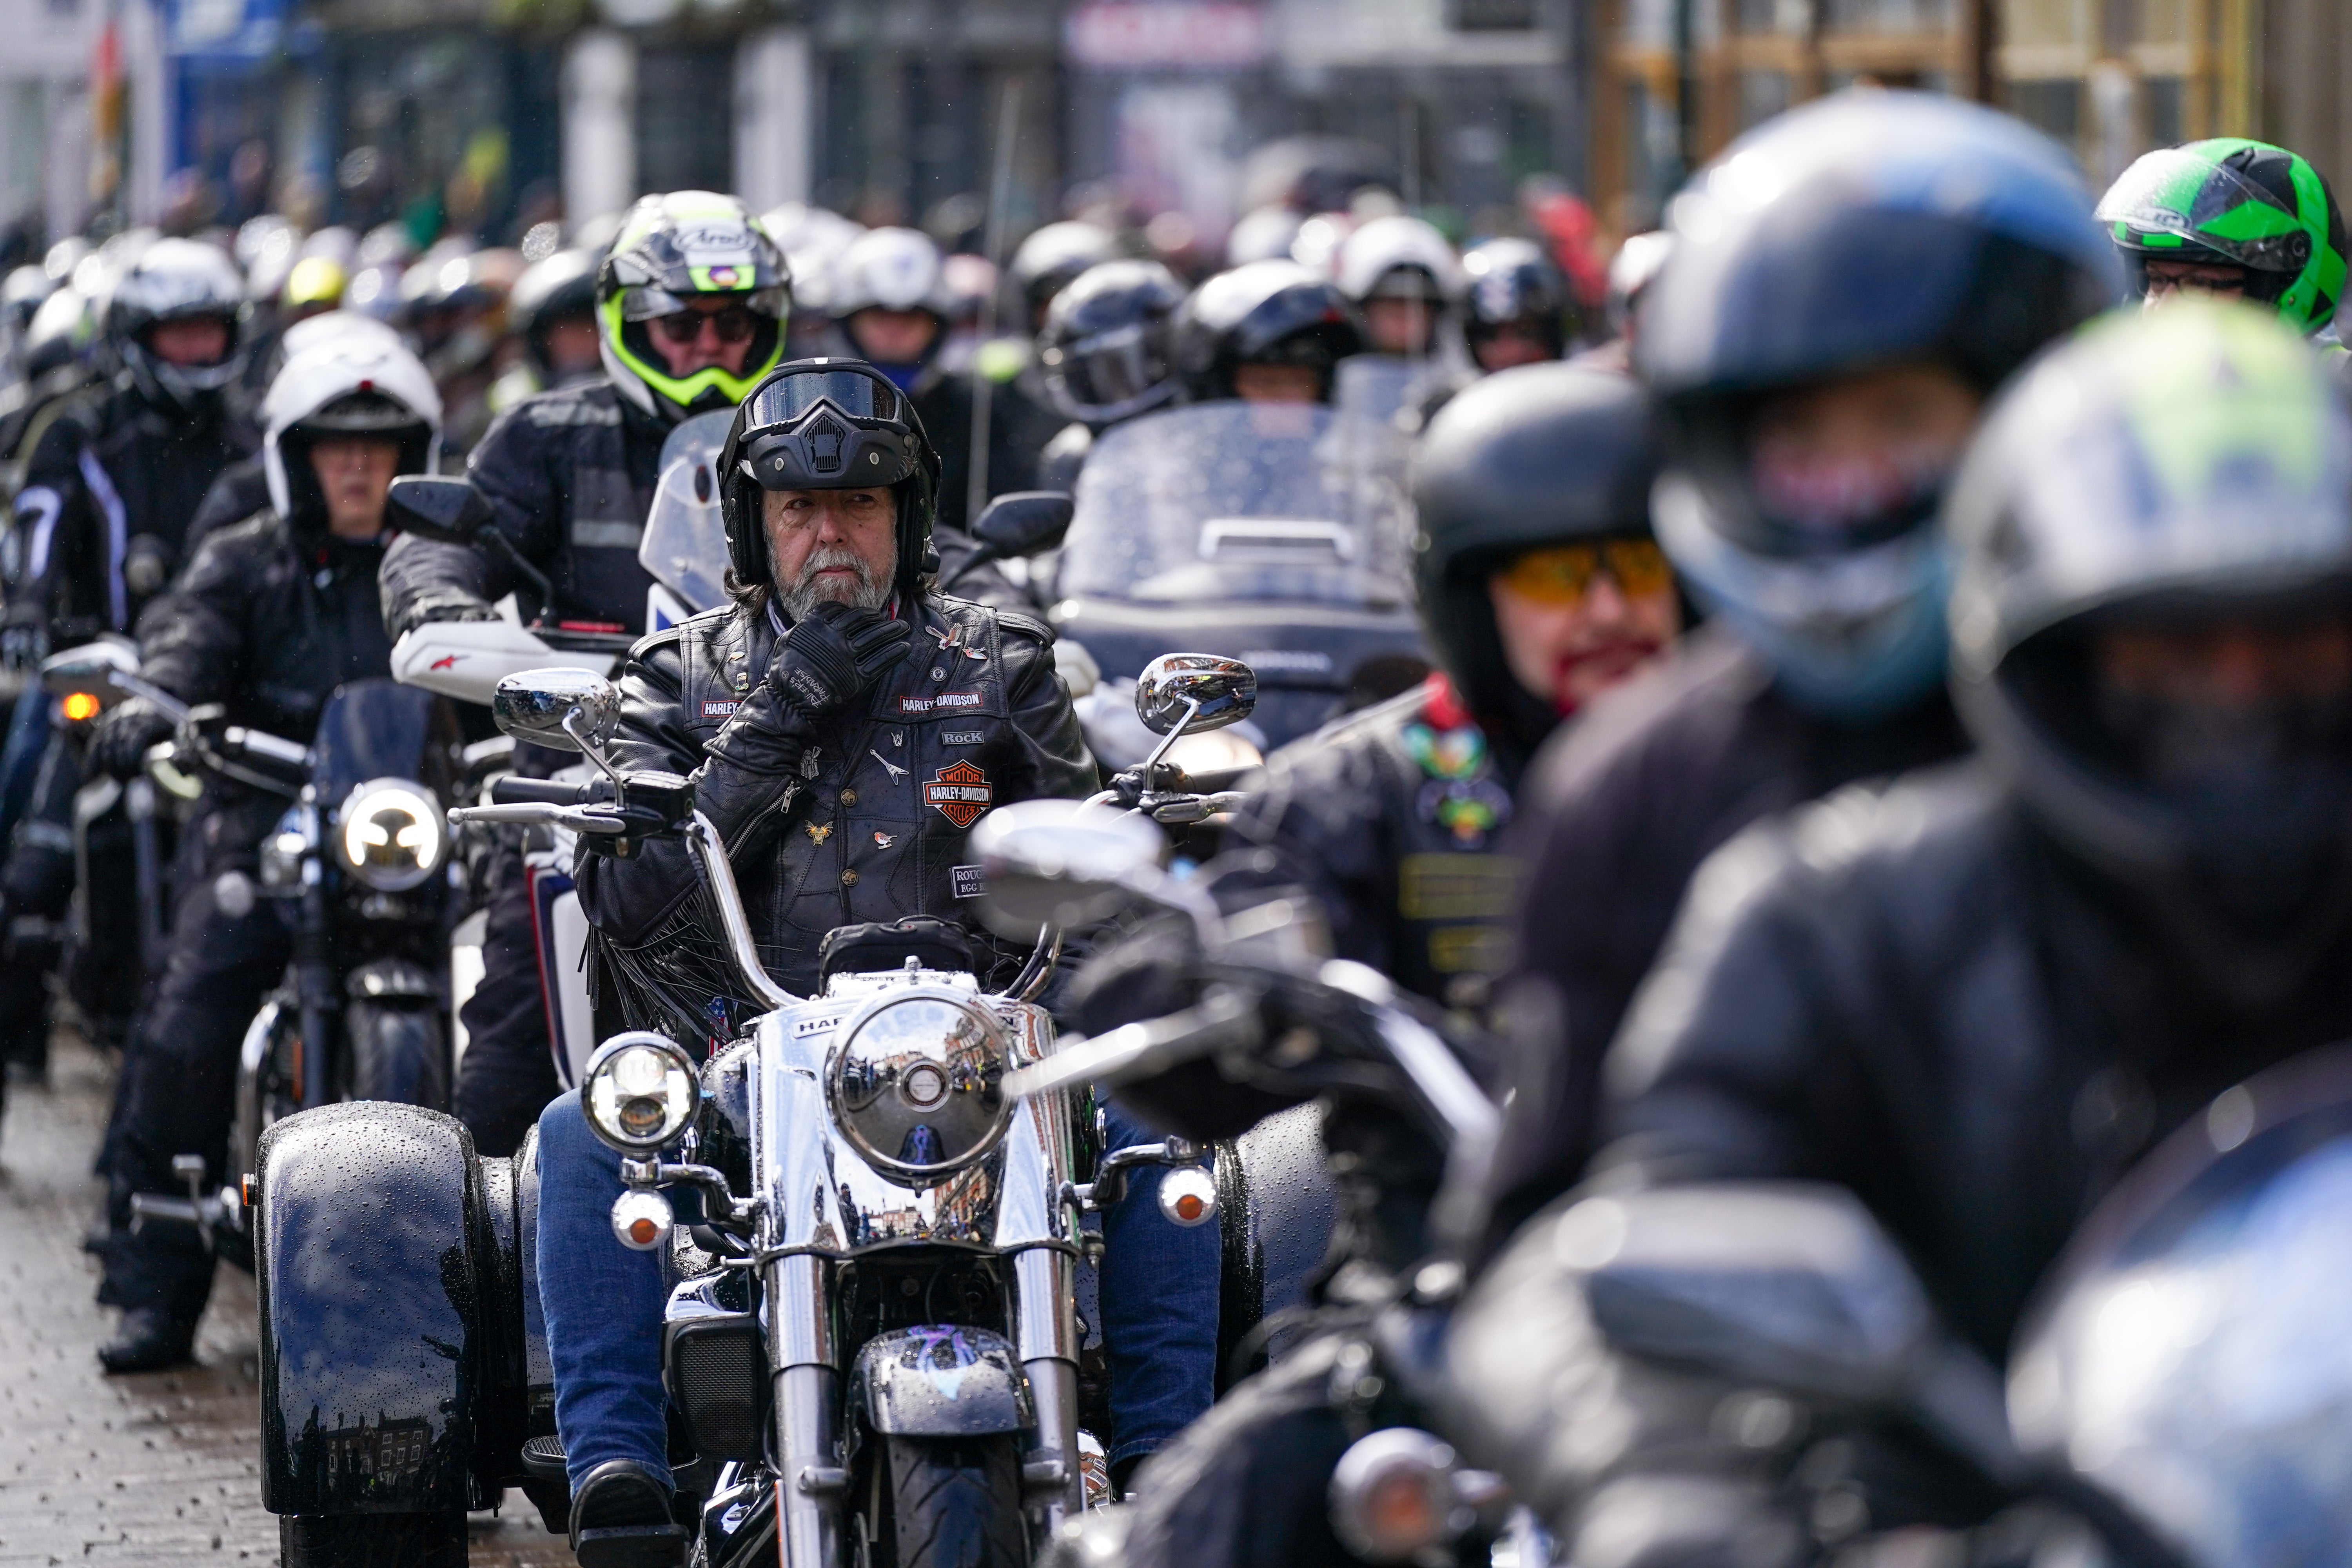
[576, 592, 1096, 1023]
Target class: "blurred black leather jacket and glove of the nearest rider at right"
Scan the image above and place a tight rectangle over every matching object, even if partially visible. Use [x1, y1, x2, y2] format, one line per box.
[1454, 764, 2352, 1563]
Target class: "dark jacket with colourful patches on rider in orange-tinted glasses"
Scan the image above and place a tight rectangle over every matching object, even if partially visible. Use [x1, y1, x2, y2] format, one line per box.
[1232, 677, 1515, 1011]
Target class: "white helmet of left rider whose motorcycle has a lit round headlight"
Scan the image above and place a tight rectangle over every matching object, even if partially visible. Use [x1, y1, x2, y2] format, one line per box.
[261, 329, 440, 517]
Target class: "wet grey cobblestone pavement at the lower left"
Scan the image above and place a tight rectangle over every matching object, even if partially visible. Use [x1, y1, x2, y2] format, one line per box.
[0, 1037, 574, 1568]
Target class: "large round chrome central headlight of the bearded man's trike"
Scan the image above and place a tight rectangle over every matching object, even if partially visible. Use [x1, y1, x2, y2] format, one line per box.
[826, 987, 1014, 1187]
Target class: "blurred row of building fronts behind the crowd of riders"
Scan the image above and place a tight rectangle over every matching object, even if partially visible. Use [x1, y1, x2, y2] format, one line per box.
[0, 0, 2352, 254]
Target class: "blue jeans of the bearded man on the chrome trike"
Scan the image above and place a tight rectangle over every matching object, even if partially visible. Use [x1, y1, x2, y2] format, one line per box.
[536, 1093, 1221, 1486]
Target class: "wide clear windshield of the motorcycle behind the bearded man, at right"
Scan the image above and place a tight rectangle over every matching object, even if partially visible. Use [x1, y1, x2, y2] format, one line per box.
[1056, 402, 1411, 609]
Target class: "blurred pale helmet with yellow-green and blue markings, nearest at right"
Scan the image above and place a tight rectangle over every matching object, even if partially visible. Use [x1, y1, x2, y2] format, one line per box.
[1945, 301, 2352, 1006]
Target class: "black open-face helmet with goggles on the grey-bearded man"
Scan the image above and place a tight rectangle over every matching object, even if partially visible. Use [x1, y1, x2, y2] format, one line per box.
[720, 360, 938, 597]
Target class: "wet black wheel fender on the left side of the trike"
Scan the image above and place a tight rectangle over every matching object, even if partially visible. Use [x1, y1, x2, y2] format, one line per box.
[254, 1100, 499, 1514]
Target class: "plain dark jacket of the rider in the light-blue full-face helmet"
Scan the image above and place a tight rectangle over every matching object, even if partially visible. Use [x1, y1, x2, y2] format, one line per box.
[1489, 628, 1969, 1241]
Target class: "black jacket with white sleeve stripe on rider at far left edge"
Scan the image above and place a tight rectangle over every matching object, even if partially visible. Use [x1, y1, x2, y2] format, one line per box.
[5, 386, 256, 649]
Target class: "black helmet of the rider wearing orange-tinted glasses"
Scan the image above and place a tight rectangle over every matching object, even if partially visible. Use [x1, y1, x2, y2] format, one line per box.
[1414, 365, 1661, 766]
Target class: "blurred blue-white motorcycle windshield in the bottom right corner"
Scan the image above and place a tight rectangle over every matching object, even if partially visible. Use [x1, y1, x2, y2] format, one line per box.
[2009, 1049, 2352, 1568]
